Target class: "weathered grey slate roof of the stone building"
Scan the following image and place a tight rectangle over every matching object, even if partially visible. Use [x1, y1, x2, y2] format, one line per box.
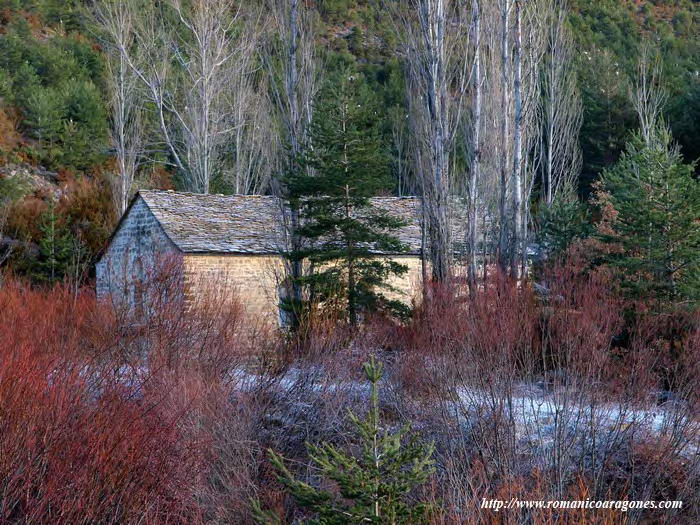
[135, 190, 442, 254]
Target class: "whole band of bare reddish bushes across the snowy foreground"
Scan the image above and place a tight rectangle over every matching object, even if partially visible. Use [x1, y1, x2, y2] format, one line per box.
[0, 254, 700, 524]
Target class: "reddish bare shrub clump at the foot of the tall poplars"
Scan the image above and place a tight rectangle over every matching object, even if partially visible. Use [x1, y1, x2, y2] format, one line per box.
[396, 272, 538, 388]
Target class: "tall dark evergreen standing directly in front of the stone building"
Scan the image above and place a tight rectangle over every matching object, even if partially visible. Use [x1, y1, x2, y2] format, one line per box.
[287, 73, 407, 324]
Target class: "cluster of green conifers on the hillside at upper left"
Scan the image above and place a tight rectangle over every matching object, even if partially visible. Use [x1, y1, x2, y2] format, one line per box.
[0, 16, 108, 171]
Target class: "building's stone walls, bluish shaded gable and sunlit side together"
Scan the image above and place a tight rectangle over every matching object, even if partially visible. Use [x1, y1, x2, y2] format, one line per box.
[96, 194, 421, 323]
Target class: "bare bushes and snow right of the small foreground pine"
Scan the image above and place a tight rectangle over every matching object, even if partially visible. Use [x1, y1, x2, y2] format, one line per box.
[399, 265, 700, 523]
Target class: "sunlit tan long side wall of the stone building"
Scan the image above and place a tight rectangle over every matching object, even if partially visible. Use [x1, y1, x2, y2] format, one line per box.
[184, 254, 421, 322]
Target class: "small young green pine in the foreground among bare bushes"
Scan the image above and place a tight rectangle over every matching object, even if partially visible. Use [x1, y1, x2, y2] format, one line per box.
[253, 358, 433, 525]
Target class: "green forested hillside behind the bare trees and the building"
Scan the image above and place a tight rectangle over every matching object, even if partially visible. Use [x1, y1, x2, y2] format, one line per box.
[0, 0, 700, 279]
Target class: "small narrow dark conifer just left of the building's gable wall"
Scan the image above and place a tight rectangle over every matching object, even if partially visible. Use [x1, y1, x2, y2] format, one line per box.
[30, 199, 74, 283]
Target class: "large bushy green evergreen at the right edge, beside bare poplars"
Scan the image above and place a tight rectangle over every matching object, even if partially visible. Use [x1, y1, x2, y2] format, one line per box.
[601, 129, 700, 303]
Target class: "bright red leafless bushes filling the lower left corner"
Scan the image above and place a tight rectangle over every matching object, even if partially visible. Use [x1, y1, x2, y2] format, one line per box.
[0, 282, 201, 523]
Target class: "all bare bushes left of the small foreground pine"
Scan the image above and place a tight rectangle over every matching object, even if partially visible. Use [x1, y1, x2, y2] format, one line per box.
[0, 261, 378, 524]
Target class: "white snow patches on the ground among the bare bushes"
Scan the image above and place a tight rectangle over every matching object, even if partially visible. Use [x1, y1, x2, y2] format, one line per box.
[231, 367, 700, 456]
